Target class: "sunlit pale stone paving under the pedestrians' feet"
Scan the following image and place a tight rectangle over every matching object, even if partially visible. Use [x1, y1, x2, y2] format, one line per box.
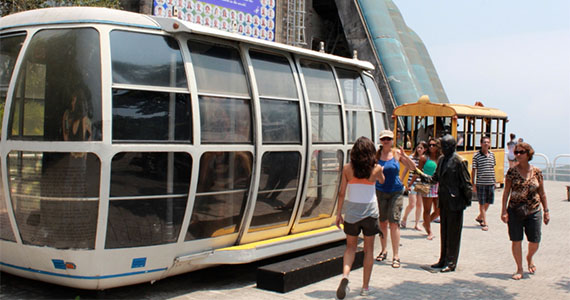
[172, 181, 570, 300]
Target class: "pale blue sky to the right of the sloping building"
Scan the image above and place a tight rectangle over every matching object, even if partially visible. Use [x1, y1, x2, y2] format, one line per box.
[393, 0, 570, 163]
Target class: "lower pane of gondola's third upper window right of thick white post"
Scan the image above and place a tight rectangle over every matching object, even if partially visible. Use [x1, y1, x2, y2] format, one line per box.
[261, 99, 301, 144]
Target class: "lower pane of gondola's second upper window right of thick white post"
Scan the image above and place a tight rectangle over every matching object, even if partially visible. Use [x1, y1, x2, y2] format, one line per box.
[200, 96, 252, 144]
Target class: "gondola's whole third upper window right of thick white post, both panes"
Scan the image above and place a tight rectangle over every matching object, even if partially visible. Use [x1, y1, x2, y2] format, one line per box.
[250, 51, 301, 144]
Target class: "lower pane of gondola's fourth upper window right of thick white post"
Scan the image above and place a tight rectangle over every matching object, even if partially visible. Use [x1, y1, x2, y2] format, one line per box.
[311, 103, 342, 143]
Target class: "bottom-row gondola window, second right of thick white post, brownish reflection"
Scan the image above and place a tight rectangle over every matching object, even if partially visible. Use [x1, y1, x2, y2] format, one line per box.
[184, 152, 253, 241]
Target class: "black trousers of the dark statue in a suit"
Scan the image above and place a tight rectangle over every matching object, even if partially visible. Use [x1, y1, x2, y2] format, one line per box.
[439, 208, 463, 268]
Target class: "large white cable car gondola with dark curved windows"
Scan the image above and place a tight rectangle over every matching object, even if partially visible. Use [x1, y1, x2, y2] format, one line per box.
[0, 7, 387, 289]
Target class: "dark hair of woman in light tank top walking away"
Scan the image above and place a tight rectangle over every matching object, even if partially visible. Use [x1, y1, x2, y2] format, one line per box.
[350, 136, 376, 178]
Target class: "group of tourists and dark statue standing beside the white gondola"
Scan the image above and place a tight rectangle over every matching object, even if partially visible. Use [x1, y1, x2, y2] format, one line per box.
[336, 130, 550, 299]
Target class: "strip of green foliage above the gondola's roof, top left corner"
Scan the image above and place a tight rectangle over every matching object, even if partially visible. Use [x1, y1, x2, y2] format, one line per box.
[0, 0, 121, 16]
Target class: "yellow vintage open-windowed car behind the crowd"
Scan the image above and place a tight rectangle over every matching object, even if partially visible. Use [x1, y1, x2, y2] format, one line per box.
[393, 96, 508, 184]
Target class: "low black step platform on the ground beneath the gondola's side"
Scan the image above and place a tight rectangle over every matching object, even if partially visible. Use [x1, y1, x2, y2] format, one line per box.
[257, 245, 364, 293]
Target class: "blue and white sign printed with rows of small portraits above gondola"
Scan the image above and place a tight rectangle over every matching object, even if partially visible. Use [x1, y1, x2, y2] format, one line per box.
[153, 0, 276, 41]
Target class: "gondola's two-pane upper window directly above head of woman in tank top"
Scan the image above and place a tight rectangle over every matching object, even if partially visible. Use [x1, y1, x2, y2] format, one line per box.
[336, 68, 372, 143]
